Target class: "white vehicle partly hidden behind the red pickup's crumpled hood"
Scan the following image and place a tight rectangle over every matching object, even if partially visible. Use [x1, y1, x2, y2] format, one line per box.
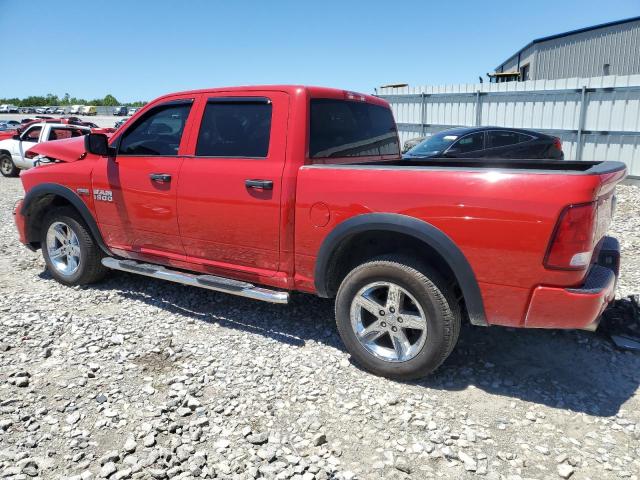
[0, 122, 91, 177]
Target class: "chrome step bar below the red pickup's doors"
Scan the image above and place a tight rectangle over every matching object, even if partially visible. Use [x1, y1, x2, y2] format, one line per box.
[102, 257, 289, 303]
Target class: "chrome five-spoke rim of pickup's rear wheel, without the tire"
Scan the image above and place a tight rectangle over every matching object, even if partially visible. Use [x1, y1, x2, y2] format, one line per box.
[350, 282, 427, 362]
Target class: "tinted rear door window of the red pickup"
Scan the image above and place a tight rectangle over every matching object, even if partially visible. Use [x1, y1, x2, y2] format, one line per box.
[196, 98, 271, 158]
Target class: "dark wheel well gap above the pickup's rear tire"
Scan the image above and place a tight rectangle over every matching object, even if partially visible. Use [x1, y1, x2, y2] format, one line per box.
[326, 230, 466, 316]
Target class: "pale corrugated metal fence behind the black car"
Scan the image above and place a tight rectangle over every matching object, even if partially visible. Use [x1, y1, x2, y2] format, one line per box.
[377, 71, 640, 177]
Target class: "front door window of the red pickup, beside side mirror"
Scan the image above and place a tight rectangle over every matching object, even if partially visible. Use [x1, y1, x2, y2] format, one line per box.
[118, 101, 191, 156]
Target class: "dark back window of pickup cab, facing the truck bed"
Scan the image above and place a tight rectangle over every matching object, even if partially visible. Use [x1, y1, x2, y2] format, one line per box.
[309, 98, 400, 158]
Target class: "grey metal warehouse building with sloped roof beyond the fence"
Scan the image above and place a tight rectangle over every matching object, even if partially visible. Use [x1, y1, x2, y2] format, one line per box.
[496, 17, 640, 82]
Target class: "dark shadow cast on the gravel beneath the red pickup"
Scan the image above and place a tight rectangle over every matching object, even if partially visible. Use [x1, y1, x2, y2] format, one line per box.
[86, 273, 640, 416]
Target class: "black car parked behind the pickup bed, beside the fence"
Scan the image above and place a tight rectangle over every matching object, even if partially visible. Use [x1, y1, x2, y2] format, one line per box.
[403, 127, 564, 160]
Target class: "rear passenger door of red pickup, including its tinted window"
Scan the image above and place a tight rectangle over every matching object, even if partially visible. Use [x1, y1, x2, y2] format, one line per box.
[178, 91, 289, 278]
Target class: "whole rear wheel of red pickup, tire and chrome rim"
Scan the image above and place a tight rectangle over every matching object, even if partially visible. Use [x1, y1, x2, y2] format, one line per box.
[336, 256, 460, 380]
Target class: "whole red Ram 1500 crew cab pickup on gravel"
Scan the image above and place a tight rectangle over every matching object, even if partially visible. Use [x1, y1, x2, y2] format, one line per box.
[15, 86, 626, 379]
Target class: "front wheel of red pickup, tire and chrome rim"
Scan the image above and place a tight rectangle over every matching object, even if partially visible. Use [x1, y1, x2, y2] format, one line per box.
[40, 207, 107, 286]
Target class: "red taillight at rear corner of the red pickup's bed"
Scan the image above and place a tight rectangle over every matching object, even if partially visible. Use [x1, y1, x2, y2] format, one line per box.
[544, 202, 597, 270]
